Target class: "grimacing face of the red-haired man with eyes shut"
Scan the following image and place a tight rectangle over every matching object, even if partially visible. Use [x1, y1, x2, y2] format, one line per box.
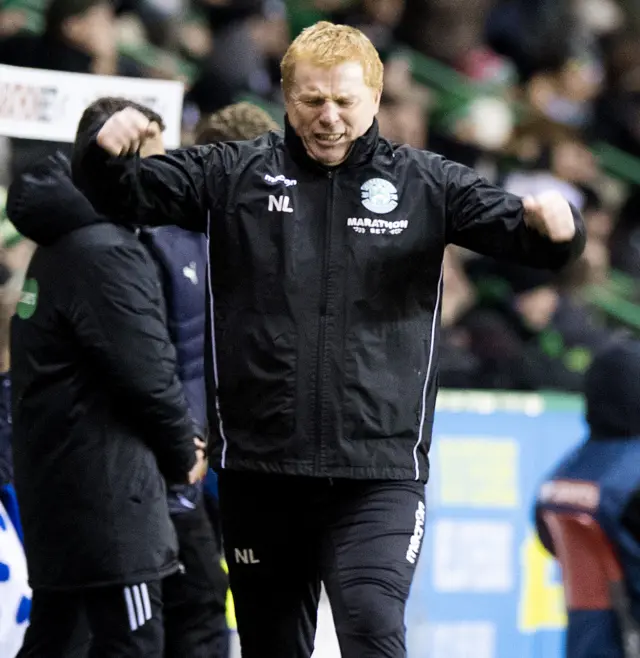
[285, 62, 380, 166]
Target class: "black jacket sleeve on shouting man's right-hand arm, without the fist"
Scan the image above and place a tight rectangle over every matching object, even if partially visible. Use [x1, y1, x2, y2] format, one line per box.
[444, 161, 586, 270]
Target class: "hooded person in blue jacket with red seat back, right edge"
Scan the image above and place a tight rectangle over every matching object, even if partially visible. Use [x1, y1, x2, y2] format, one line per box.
[536, 338, 640, 658]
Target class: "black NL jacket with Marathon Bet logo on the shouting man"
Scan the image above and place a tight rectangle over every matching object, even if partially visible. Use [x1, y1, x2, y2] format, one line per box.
[73, 122, 585, 480]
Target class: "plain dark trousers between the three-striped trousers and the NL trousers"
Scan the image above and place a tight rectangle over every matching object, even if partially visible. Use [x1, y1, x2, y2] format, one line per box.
[162, 505, 229, 658]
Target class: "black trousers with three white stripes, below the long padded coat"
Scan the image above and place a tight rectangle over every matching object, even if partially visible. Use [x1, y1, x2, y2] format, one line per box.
[17, 580, 164, 658]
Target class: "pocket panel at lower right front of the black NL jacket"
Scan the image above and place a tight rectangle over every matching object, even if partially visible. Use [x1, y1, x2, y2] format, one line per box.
[344, 320, 434, 440]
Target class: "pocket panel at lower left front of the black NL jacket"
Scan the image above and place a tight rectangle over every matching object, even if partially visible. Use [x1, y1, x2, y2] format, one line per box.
[217, 311, 297, 437]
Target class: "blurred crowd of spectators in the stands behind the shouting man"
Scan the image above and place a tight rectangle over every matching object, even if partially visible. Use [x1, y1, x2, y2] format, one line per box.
[0, 0, 640, 391]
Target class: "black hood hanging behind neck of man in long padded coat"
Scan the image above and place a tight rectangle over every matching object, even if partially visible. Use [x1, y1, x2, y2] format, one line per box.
[7, 153, 107, 246]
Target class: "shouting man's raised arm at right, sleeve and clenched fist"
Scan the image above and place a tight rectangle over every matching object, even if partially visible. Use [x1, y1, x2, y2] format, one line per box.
[444, 162, 586, 270]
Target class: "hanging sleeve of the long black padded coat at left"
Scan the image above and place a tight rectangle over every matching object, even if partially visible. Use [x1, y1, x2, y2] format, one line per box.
[70, 238, 202, 483]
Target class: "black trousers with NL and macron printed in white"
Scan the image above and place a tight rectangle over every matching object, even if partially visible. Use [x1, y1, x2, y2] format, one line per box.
[219, 470, 425, 658]
